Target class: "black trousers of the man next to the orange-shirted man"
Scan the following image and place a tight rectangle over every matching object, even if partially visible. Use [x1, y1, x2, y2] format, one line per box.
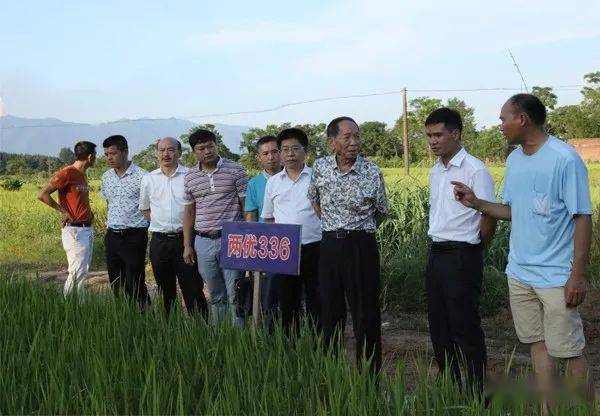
[104, 228, 150, 308]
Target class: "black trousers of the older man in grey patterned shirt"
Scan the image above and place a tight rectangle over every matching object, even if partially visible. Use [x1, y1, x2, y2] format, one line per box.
[319, 232, 381, 372]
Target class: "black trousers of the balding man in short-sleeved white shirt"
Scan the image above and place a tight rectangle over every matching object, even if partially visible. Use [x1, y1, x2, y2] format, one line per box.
[150, 233, 208, 319]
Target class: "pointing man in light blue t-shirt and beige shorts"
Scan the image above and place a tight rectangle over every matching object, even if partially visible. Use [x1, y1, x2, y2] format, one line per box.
[453, 94, 592, 395]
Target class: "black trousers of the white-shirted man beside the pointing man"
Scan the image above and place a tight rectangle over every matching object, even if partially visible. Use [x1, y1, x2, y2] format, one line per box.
[426, 242, 487, 392]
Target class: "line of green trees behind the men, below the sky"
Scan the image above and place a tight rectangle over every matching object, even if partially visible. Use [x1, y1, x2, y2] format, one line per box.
[0, 71, 600, 177]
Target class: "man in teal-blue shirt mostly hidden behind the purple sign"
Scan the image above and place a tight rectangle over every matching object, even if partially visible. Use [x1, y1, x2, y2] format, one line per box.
[244, 136, 281, 330]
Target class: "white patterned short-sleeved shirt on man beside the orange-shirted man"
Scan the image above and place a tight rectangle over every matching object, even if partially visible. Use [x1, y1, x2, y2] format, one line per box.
[100, 162, 148, 230]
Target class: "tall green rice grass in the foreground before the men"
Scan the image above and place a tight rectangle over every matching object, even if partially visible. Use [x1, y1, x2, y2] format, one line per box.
[0, 278, 587, 415]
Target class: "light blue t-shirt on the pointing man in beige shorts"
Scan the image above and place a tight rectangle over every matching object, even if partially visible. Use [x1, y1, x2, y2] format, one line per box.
[502, 136, 592, 288]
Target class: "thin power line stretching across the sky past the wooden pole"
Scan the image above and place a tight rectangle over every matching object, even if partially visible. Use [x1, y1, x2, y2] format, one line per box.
[0, 84, 585, 131]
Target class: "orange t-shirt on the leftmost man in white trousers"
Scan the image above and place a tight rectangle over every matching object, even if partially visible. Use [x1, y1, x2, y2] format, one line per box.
[50, 166, 92, 222]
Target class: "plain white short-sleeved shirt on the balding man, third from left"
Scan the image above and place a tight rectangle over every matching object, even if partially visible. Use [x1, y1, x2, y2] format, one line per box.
[139, 165, 192, 233]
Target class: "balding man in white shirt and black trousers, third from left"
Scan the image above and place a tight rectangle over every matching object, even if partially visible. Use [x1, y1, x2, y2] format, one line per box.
[140, 137, 208, 319]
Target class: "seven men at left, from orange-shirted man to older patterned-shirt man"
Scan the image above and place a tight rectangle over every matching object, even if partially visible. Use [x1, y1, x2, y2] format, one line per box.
[39, 117, 388, 369]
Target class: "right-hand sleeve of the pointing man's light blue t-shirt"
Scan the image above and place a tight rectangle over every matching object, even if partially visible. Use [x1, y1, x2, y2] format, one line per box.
[561, 158, 592, 215]
